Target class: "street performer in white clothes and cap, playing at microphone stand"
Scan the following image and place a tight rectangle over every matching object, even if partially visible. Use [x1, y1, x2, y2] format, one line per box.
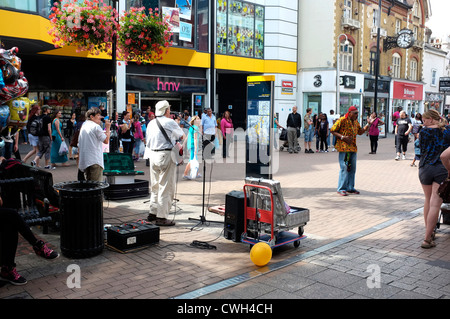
[146, 101, 184, 226]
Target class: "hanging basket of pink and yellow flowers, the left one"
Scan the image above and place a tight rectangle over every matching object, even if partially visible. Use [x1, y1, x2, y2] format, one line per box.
[49, 0, 118, 55]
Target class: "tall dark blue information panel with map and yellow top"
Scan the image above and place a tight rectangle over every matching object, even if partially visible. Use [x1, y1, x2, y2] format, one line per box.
[246, 76, 275, 179]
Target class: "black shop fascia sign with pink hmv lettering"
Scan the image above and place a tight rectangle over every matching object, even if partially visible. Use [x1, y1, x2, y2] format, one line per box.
[127, 74, 207, 94]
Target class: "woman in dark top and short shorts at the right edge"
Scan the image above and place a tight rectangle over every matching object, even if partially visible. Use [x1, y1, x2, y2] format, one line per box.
[419, 110, 450, 248]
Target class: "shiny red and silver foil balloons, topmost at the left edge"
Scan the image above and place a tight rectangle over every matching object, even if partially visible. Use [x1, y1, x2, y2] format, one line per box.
[0, 47, 28, 104]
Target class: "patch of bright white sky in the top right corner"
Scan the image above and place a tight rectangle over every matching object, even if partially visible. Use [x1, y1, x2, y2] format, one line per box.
[426, 0, 450, 38]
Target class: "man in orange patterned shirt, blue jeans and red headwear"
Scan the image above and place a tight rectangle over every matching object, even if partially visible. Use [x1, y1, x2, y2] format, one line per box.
[331, 106, 369, 196]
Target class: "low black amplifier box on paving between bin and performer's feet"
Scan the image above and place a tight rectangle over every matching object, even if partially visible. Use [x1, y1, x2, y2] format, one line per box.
[106, 222, 159, 251]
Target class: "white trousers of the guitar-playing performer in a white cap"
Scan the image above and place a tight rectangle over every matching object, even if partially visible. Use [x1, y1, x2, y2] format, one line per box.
[150, 151, 176, 218]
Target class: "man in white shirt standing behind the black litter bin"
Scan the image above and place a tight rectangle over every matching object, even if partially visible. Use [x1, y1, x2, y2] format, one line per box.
[78, 107, 111, 182]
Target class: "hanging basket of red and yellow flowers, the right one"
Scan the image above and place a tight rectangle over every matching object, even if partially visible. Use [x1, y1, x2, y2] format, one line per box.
[117, 7, 172, 64]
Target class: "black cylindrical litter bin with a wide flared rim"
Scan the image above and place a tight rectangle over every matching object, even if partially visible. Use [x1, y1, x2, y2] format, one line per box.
[53, 181, 109, 258]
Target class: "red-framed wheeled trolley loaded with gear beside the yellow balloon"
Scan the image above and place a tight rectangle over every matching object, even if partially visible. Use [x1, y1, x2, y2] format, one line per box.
[241, 178, 309, 248]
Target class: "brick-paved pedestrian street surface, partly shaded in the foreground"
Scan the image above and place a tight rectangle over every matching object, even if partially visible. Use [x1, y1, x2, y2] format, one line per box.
[0, 135, 450, 308]
